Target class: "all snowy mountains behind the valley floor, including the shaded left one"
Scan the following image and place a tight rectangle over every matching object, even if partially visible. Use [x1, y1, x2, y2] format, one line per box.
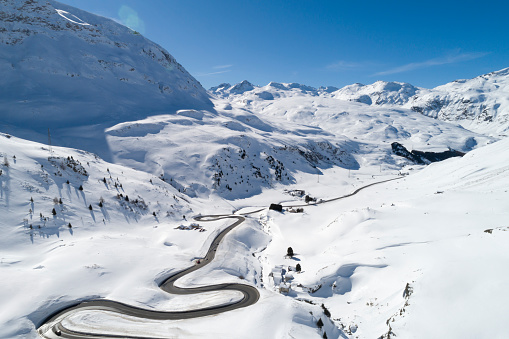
[0, 0, 502, 198]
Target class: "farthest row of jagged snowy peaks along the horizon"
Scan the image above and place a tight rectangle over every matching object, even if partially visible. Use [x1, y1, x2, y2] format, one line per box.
[209, 68, 509, 135]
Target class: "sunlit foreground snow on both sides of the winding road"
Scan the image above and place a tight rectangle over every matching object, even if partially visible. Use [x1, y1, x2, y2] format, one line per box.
[0, 129, 509, 338]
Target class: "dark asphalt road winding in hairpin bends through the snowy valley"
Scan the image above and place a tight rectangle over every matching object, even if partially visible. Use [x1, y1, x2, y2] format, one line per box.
[37, 177, 401, 339]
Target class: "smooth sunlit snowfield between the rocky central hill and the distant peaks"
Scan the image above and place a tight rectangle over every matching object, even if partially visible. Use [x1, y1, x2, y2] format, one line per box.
[215, 94, 490, 151]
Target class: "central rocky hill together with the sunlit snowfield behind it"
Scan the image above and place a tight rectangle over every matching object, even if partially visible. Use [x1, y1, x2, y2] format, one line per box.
[102, 94, 492, 200]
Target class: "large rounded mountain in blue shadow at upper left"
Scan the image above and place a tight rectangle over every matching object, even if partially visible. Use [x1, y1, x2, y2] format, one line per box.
[0, 0, 212, 157]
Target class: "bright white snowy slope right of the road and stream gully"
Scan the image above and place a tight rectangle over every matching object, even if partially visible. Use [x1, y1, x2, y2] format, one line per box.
[254, 139, 509, 338]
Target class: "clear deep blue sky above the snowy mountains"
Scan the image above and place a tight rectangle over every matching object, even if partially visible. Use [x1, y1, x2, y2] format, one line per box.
[57, 0, 509, 88]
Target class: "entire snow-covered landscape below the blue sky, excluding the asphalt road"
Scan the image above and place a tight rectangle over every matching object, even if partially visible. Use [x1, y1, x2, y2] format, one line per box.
[0, 0, 509, 339]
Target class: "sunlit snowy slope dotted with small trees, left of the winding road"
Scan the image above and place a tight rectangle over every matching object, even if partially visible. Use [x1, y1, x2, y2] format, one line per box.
[0, 134, 232, 338]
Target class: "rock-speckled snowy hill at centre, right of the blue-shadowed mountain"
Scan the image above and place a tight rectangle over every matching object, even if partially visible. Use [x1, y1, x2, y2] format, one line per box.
[107, 109, 359, 200]
